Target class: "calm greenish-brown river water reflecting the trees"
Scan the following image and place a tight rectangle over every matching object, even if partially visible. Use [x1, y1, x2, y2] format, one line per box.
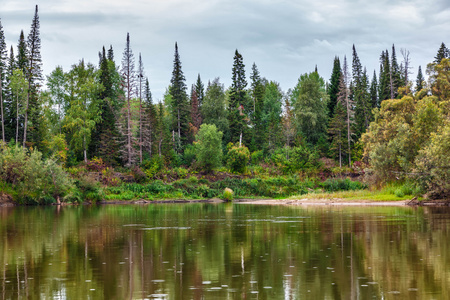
[0, 204, 450, 299]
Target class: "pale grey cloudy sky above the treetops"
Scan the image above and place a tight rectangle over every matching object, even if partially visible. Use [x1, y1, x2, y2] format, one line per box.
[0, 0, 450, 100]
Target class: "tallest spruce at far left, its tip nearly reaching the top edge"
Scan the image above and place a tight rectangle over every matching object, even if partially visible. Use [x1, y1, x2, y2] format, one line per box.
[23, 5, 42, 147]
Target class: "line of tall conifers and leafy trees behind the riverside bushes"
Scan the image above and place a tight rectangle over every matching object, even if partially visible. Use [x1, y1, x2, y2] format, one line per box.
[0, 6, 449, 176]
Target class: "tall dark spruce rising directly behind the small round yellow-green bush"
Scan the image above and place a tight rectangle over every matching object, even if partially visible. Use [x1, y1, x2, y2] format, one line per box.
[228, 50, 250, 144]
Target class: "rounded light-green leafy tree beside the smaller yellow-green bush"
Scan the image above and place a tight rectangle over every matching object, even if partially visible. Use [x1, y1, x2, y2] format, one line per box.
[195, 124, 223, 172]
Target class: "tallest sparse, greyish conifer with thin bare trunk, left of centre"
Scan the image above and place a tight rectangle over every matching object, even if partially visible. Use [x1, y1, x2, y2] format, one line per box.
[121, 33, 136, 166]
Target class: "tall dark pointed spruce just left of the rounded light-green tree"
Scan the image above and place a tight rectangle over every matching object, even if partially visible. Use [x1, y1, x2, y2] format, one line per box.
[169, 43, 190, 153]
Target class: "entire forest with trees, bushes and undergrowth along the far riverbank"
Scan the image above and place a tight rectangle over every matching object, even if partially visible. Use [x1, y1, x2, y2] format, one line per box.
[0, 6, 450, 204]
